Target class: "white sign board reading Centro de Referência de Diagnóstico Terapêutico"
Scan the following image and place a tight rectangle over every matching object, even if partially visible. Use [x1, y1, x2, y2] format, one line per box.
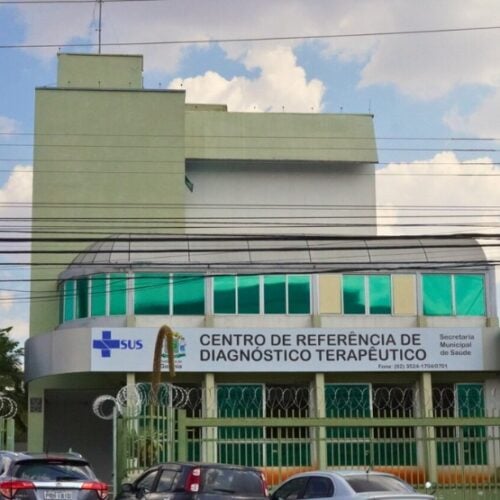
[90, 328, 483, 373]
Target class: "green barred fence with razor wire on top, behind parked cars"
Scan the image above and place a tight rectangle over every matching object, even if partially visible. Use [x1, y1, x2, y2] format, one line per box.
[95, 384, 500, 500]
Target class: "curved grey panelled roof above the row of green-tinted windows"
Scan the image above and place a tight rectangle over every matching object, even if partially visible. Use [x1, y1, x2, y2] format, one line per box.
[59, 234, 488, 280]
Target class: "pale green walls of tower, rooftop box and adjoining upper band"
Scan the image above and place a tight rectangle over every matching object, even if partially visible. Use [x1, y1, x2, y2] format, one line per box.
[29, 54, 377, 456]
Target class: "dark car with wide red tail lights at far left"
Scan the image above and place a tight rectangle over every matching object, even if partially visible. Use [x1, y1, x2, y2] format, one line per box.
[0, 451, 108, 500]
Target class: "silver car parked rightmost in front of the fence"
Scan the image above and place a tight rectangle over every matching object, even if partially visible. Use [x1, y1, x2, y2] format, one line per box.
[270, 470, 435, 500]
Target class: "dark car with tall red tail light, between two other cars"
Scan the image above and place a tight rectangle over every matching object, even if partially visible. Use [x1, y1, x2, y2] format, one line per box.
[116, 462, 269, 500]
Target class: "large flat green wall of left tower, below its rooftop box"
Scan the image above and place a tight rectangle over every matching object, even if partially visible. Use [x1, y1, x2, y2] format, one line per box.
[31, 89, 186, 335]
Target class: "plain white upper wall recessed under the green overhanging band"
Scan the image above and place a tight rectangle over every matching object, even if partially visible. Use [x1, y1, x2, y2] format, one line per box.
[186, 160, 376, 236]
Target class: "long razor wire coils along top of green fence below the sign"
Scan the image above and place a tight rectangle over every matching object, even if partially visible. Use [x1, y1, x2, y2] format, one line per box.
[94, 383, 496, 419]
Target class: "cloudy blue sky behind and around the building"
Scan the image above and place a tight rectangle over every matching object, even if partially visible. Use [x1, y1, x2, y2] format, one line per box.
[0, 0, 500, 338]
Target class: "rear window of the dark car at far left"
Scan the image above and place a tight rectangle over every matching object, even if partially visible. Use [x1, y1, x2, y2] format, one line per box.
[13, 460, 94, 481]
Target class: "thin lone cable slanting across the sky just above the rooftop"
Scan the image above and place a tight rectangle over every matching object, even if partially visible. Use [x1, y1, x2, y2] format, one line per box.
[0, 24, 500, 49]
